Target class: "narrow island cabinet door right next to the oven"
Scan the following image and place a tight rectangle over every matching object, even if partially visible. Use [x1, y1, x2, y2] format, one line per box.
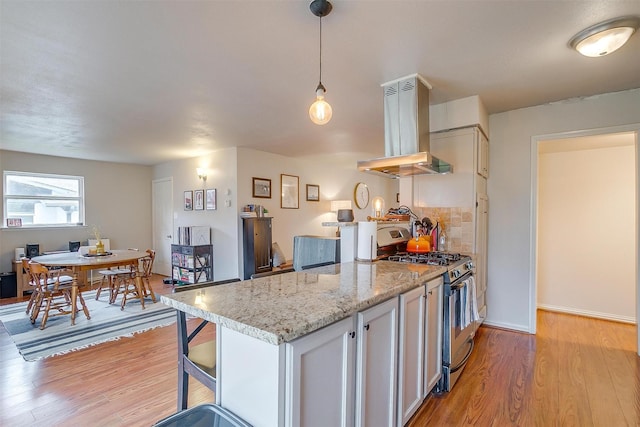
[424, 278, 443, 397]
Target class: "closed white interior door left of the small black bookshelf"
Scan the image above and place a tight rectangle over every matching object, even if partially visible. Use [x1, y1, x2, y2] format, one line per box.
[151, 177, 173, 276]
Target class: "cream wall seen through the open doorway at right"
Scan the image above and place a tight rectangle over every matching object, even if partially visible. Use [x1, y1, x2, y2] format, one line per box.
[537, 141, 637, 322]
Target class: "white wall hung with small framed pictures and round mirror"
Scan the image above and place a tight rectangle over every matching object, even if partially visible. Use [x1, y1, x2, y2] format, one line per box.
[153, 148, 398, 280]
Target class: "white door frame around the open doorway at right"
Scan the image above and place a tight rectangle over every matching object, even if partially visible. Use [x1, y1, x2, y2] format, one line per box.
[529, 123, 640, 356]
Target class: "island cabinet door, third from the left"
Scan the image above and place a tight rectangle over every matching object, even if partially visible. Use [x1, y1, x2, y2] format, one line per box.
[398, 286, 426, 426]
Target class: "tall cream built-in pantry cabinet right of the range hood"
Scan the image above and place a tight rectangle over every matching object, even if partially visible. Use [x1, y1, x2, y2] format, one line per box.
[414, 126, 489, 326]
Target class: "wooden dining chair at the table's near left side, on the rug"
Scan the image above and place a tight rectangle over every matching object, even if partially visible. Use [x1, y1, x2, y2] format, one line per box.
[29, 261, 89, 329]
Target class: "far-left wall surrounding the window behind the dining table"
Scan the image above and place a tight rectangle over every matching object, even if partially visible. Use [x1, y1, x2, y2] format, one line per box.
[0, 150, 152, 272]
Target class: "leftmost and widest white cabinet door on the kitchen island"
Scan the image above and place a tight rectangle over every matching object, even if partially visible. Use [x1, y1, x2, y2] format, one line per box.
[286, 317, 356, 427]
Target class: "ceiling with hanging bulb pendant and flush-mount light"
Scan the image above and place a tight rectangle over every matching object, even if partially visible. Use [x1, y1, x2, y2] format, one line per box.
[0, 0, 640, 165]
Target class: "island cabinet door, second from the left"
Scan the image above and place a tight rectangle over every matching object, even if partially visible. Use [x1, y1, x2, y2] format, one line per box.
[356, 298, 398, 427]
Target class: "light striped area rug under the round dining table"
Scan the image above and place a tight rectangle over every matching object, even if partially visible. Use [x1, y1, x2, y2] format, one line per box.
[0, 291, 176, 361]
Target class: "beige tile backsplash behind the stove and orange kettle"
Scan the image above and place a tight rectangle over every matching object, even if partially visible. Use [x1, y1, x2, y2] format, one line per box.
[413, 207, 474, 254]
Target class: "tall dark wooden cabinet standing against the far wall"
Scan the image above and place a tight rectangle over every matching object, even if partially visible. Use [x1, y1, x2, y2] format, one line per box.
[242, 217, 271, 280]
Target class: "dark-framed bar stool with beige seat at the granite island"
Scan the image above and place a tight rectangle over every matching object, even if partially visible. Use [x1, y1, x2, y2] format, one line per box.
[173, 278, 240, 411]
